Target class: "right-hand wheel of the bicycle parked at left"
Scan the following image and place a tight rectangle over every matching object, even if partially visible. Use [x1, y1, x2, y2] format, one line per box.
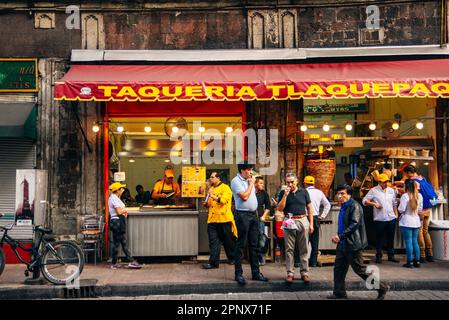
[41, 241, 84, 285]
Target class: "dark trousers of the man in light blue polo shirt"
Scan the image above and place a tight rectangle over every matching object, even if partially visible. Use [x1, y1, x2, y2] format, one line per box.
[234, 210, 260, 276]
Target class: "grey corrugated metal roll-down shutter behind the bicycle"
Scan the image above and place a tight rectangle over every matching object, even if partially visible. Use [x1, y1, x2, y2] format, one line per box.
[0, 138, 36, 239]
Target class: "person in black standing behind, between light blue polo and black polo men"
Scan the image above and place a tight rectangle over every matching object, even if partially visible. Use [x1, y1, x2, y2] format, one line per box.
[254, 176, 271, 266]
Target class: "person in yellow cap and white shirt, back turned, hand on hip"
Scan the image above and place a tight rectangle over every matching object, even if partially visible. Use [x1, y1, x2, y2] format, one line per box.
[304, 176, 331, 267]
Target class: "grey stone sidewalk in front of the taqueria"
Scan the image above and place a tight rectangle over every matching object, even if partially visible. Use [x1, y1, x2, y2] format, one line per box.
[0, 255, 449, 299]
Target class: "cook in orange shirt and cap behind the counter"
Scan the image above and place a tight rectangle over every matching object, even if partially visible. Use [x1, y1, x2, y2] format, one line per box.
[152, 166, 181, 205]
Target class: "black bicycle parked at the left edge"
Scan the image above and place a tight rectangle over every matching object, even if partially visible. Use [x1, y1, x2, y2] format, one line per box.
[0, 213, 84, 285]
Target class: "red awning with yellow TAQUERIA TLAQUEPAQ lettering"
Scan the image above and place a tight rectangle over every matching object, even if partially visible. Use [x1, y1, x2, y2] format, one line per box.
[55, 59, 449, 101]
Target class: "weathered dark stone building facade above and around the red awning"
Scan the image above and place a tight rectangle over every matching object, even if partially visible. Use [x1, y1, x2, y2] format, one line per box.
[0, 0, 447, 234]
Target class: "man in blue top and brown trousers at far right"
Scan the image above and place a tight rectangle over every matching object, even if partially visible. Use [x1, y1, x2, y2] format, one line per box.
[403, 165, 437, 263]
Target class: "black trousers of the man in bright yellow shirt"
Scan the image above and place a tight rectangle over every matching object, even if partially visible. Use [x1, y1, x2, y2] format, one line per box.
[207, 222, 236, 266]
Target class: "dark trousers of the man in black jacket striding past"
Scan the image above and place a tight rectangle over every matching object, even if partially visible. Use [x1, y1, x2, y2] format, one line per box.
[334, 245, 387, 296]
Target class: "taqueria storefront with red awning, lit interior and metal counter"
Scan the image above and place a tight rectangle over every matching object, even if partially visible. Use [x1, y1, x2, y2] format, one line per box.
[54, 59, 449, 256]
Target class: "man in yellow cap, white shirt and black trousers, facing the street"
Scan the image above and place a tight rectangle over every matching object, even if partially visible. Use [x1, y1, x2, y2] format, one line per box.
[362, 173, 399, 263]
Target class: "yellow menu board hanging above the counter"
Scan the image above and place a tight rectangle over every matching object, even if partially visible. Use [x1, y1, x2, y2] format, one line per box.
[182, 166, 206, 198]
